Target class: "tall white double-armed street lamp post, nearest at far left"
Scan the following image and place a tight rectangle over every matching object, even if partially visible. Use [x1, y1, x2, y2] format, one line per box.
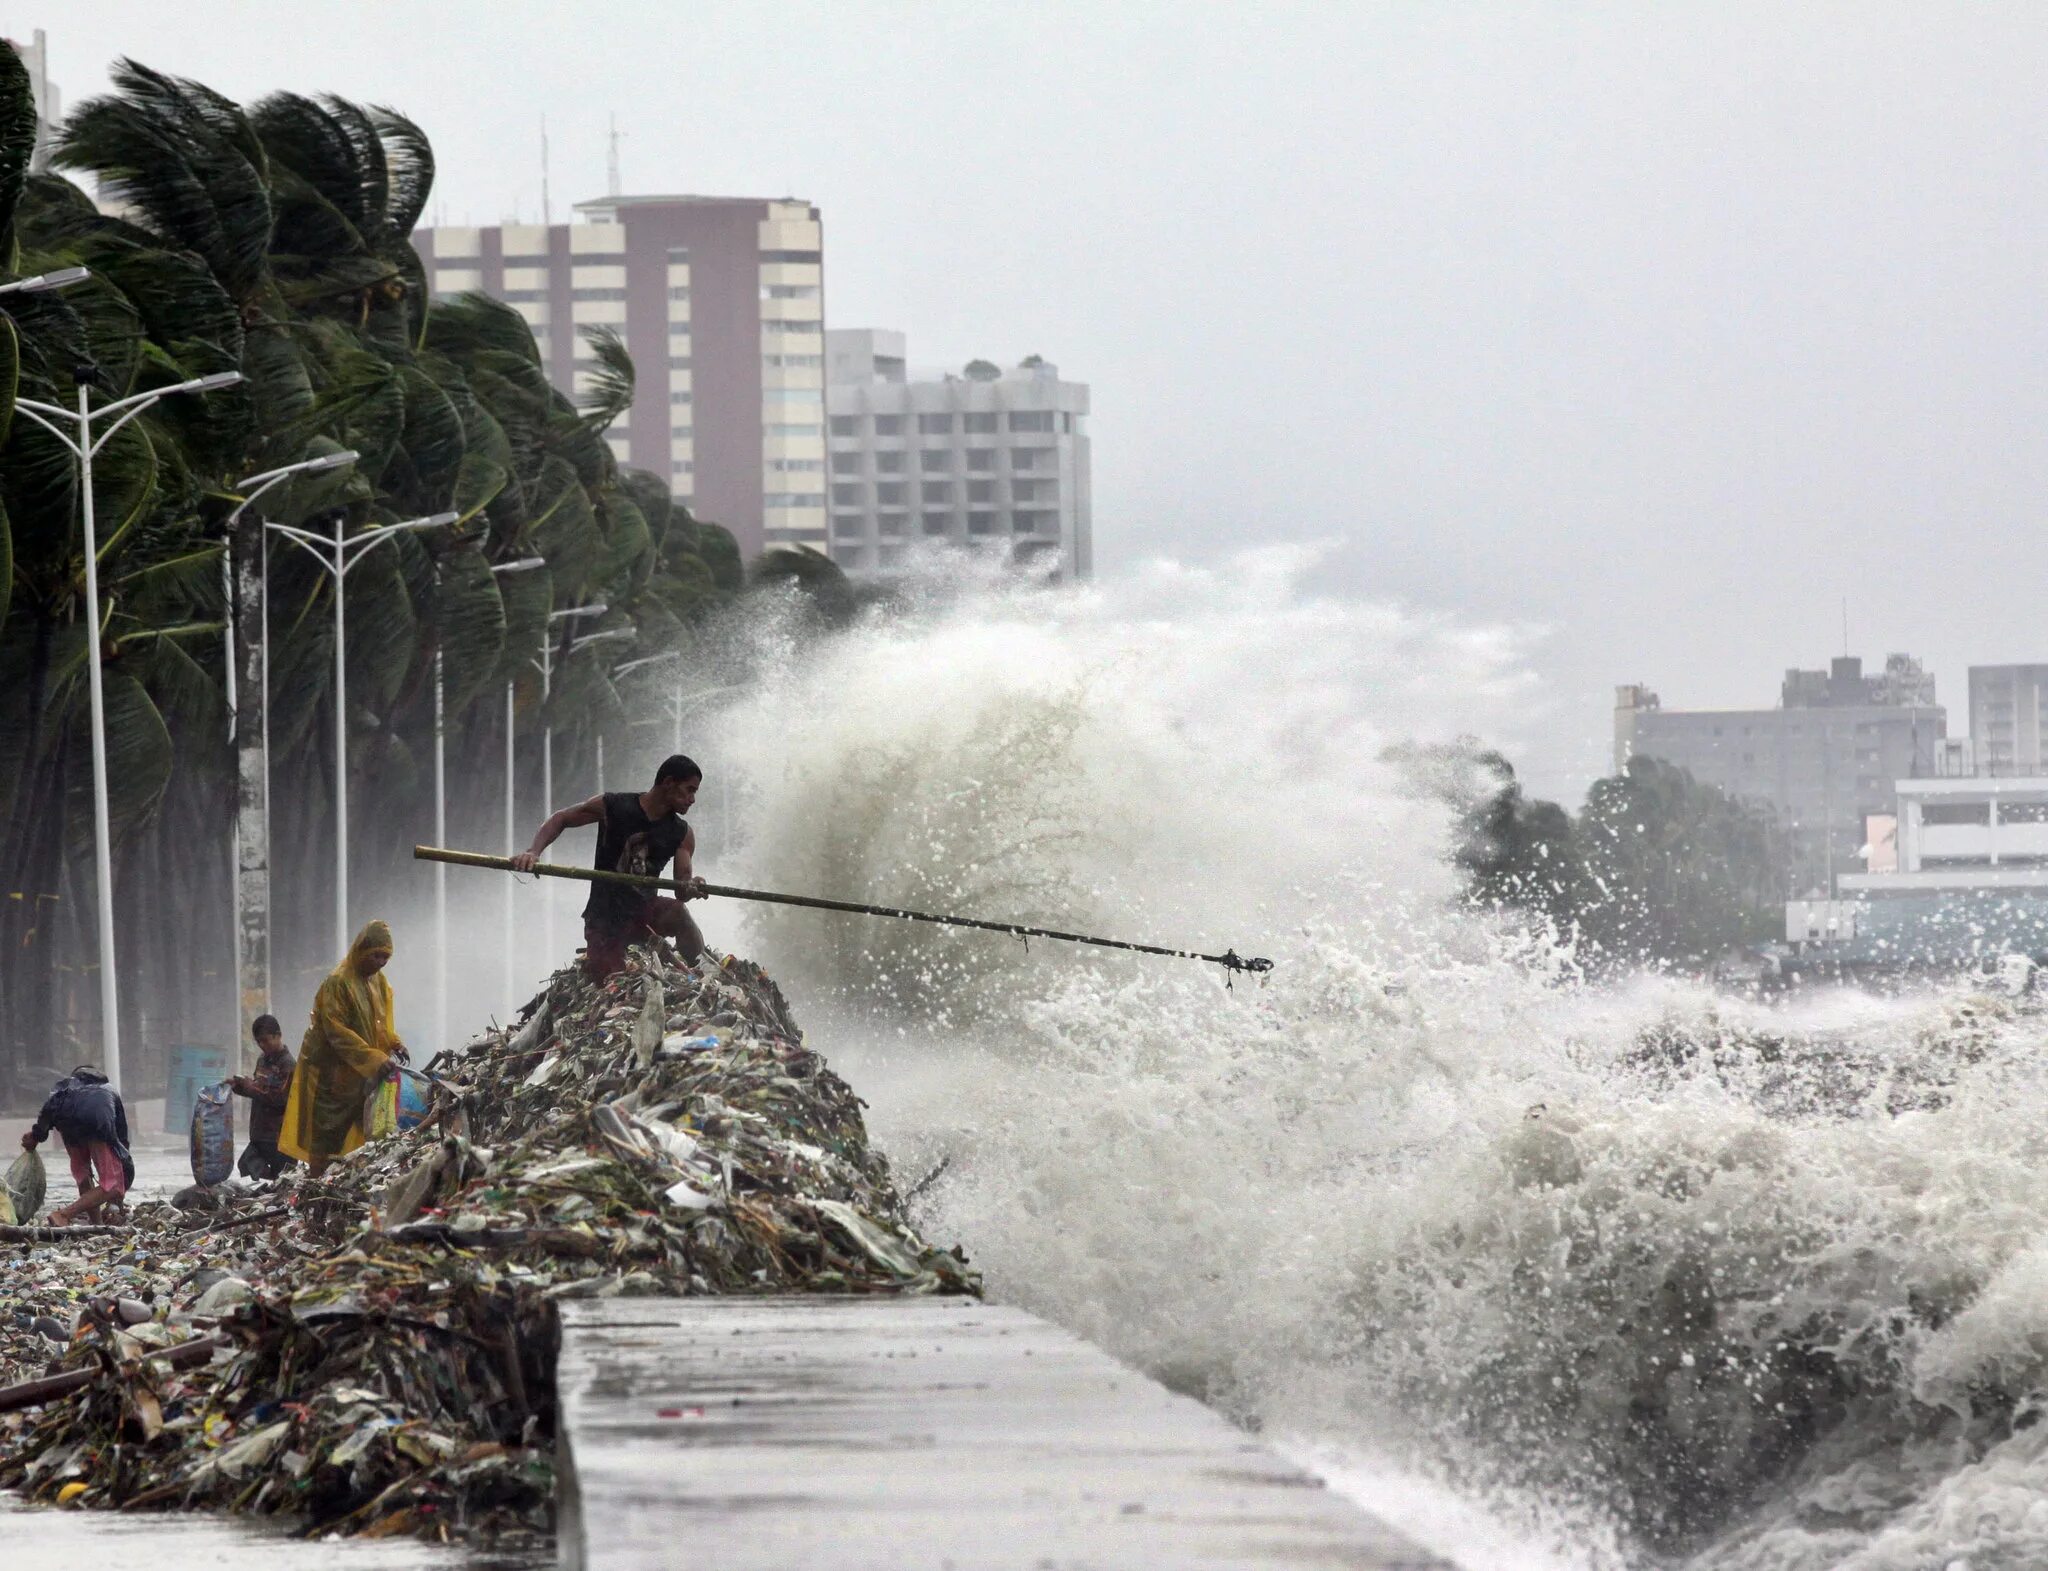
[12, 356, 242, 1090]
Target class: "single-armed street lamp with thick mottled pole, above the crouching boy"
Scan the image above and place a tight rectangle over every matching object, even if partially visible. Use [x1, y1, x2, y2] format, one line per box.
[221, 453, 356, 1053]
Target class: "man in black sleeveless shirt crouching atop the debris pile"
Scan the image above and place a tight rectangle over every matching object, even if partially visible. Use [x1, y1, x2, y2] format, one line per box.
[512, 754, 705, 981]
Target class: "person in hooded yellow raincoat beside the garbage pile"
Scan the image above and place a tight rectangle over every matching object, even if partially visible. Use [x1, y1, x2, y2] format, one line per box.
[276, 922, 406, 1178]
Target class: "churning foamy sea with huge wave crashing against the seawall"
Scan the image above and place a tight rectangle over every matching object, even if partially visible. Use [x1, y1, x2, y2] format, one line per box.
[696, 551, 2048, 1571]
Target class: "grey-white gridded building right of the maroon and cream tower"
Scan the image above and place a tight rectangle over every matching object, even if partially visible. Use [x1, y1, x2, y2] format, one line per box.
[825, 328, 1094, 578]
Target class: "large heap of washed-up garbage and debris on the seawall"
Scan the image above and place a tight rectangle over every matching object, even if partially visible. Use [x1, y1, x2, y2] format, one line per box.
[0, 946, 979, 1542]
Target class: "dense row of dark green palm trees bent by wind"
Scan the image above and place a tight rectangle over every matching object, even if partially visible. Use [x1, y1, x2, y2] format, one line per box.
[0, 51, 761, 1069]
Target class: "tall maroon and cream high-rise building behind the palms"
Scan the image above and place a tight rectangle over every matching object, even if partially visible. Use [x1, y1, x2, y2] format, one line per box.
[414, 197, 827, 557]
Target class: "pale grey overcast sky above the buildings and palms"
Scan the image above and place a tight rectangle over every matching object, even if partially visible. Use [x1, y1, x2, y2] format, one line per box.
[28, 0, 2048, 797]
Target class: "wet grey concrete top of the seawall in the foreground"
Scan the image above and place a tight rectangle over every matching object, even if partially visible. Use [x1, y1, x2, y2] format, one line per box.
[557, 1299, 1446, 1571]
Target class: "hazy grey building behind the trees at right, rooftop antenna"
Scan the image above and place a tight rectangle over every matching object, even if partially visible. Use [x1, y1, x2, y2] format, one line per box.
[1614, 655, 1948, 864]
